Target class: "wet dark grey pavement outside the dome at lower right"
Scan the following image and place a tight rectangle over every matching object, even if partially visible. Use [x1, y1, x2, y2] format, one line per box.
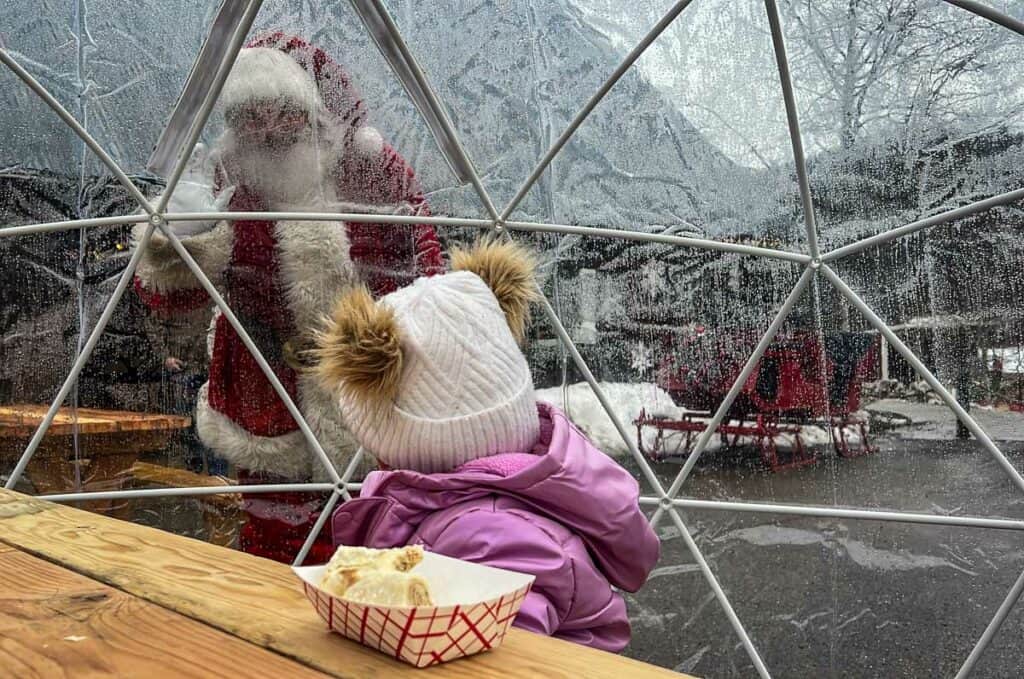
[627, 432, 1024, 677]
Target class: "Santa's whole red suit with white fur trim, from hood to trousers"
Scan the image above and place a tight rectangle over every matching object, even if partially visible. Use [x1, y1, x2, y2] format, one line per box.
[135, 34, 443, 563]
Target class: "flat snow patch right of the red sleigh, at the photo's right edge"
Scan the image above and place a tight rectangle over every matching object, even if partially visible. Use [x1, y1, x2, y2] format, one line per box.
[864, 398, 1024, 441]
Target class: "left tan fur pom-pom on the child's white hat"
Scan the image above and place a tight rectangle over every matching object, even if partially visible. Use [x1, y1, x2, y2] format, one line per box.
[313, 286, 402, 407]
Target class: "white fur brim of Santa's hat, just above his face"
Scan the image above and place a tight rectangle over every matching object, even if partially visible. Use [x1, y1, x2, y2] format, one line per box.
[220, 47, 321, 111]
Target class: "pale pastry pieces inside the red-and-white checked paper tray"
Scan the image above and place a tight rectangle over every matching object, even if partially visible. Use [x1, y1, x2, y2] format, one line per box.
[319, 546, 431, 606]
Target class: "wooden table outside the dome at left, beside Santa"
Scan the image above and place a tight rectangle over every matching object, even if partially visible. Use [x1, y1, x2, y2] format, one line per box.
[0, 405, 191, 511]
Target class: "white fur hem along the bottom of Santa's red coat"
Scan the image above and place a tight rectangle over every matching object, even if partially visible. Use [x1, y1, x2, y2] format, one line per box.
[196, 383, 313, 480]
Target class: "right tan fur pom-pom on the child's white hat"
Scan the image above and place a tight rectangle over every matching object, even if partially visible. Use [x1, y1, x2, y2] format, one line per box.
[452, 239, 540, 342]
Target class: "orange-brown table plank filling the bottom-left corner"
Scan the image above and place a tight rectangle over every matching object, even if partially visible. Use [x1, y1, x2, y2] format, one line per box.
[0, 548, 326, 679]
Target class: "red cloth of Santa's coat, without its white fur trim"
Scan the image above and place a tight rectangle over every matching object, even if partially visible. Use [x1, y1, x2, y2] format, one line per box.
[135, 146, 444, 436]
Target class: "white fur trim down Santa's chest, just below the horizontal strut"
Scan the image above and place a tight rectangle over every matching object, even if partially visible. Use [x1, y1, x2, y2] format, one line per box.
[274, 221, 356, 334]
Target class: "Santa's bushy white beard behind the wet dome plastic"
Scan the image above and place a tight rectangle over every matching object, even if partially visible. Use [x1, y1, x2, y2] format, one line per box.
[220, 131, 338, 210]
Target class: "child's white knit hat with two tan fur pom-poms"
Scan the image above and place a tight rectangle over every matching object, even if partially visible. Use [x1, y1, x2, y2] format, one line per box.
[318, 244, 540, 473]
